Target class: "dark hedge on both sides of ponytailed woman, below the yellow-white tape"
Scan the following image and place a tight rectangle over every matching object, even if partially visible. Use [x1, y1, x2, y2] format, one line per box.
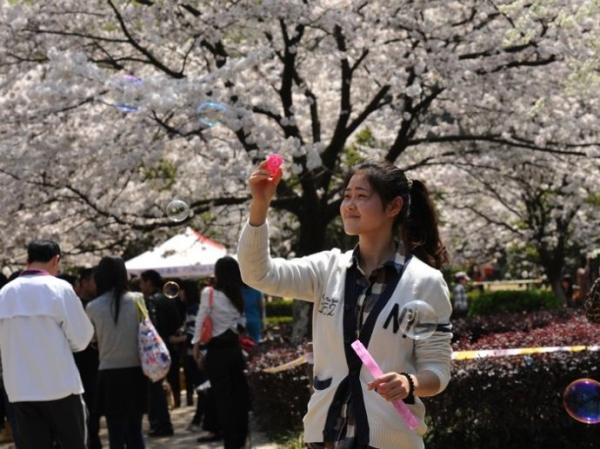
[249, 350, 600, 449]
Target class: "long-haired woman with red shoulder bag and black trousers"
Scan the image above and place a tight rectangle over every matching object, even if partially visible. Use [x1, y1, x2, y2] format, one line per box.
[192, 257, 249, 449]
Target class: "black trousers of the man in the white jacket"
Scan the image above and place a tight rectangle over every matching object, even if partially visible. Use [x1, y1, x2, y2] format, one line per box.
[13, 395, 87, 449]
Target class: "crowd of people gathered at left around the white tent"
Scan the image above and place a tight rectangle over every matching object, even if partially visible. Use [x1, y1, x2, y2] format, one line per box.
[0, 240, 262, 449]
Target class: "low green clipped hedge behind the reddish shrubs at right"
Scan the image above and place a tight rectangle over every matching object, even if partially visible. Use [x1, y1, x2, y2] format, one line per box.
[469, 290, 562, 316]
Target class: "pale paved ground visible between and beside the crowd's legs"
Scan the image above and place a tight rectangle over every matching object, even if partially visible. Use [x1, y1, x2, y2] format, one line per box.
[0, 407, 277, 449]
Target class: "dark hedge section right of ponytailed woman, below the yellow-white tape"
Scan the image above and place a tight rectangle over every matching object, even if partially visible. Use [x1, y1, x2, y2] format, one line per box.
[425, 352, 600, 449]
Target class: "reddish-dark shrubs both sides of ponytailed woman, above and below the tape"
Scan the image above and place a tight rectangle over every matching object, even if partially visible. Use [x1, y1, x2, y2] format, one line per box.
[249, 310, 600, 449]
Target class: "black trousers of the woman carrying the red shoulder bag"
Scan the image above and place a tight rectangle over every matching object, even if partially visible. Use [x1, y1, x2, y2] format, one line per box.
[206, 332, 250, 449]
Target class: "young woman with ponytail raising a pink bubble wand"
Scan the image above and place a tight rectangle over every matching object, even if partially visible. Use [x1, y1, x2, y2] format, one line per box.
[238, 163, 451, 449]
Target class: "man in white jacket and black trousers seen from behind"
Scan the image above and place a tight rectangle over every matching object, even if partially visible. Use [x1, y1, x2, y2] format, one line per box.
[0, 240, 94, 449]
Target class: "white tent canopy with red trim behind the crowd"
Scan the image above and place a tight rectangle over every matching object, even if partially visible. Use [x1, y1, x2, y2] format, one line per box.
[125, 228, 227, 278]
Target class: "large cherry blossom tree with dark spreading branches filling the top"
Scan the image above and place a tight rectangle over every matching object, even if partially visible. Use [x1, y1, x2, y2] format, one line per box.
[0, 0, 598, 332]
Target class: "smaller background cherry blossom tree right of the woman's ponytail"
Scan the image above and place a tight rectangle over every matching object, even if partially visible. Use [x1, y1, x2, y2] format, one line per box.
[446, 147, 600, 300]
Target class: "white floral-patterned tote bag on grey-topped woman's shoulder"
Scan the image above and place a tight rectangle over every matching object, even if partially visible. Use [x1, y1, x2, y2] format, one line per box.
[134, 297, 171, 382]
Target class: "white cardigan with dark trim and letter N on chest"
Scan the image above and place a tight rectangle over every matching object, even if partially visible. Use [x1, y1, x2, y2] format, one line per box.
[238, 224, 452, 449]
